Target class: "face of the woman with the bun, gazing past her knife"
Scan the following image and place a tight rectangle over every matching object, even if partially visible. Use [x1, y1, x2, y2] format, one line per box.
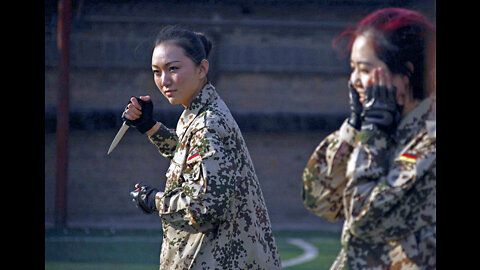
[152, 42, 208, 108]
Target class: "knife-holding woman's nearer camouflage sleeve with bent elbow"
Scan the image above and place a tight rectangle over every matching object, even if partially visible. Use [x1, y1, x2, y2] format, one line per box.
[157, 121, 238, 231]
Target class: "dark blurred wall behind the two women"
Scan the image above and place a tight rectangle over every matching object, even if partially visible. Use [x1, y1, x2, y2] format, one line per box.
[45, 0, 436, 232]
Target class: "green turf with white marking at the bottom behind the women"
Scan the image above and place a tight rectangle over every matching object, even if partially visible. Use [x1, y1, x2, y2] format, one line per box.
[45, 228, 340, 270]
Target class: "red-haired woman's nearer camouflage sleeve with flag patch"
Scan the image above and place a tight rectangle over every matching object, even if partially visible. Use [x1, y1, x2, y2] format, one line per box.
[344, 127, 436, 241]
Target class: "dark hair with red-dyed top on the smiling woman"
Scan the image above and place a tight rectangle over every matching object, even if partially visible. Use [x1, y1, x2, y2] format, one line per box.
[332, 8, 436, 99]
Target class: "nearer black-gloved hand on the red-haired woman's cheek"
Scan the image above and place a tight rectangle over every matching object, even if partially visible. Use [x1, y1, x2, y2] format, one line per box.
[362, 84, 402, 134]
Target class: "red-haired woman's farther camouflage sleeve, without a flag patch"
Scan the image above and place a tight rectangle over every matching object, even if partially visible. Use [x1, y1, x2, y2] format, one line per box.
[302, 120, 357, 222]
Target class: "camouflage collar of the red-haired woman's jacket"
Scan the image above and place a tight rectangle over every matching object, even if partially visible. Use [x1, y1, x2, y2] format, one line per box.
[394, 95, 436, 144]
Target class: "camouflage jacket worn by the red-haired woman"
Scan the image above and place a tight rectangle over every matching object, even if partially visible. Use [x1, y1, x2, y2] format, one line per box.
[302, 96, 436, 269]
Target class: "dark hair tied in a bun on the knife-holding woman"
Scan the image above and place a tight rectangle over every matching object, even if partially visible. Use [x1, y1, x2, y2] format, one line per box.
[154, 26, 212, 65]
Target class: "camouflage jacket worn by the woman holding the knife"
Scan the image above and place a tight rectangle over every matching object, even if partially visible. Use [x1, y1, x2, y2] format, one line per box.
[150, 83, 280, 270]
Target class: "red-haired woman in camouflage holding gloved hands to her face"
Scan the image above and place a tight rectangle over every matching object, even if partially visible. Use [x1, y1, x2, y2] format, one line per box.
[302, 8, 436, 269]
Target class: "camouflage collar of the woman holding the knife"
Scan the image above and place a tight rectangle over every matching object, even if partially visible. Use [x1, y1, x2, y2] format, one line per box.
[176, 82, 215, 138]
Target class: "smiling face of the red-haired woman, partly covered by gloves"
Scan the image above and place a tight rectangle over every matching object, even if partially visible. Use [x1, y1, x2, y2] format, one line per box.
[350, 35, 409, 105]
